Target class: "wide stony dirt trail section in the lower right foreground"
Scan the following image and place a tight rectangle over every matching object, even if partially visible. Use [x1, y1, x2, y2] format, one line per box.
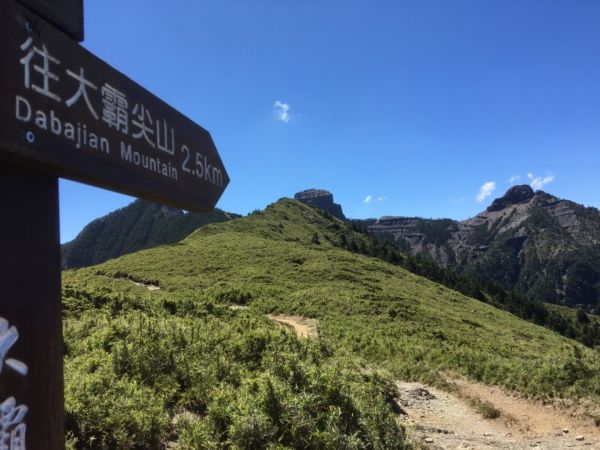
[398, 380, 600, 450]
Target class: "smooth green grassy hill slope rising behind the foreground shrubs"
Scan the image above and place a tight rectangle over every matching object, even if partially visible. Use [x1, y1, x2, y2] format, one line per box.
[64, 200, 600, 400]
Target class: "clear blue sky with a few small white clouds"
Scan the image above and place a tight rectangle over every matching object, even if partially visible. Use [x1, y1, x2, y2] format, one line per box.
[60, 0, 600, 242]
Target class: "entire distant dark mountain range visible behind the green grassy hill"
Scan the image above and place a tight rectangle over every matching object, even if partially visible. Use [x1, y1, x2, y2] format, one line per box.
[62, 185, 600, 311]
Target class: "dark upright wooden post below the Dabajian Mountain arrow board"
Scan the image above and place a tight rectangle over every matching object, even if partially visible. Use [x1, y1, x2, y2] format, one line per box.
[0, 166, 64, 450]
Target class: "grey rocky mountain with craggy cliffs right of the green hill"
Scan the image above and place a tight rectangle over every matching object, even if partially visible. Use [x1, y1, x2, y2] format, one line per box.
[368, 186, 600, 309]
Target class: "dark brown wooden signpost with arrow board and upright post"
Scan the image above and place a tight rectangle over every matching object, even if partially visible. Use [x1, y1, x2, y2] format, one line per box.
[0, 0, 229, 450]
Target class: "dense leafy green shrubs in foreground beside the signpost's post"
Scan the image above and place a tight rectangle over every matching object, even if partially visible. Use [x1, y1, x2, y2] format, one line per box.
[65, 294, 404, 449]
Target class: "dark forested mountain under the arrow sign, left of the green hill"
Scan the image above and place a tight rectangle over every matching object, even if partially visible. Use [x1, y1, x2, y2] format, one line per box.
[61, 200, 240, 269]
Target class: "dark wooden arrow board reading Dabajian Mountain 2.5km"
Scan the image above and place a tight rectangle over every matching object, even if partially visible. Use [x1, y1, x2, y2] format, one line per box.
[0, 0, 229, 211]
